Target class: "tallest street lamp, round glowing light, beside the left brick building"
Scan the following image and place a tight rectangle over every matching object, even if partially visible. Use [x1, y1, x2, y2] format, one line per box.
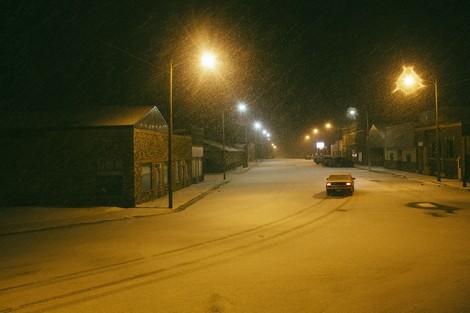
[167, 52, 216, 209]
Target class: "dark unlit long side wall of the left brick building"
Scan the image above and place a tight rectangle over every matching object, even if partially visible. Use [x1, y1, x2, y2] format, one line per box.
[1, 128, 134, 206]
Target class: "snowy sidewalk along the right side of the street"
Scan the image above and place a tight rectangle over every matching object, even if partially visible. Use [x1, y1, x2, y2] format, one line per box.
[355, 164, 470, 191]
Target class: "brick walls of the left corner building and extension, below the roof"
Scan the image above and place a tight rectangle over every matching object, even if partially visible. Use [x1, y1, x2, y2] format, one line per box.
[0, 127, 191, 207]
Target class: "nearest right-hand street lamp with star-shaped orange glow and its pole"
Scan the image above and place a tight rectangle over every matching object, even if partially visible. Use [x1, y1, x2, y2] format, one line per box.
[393, 66, 441, 181]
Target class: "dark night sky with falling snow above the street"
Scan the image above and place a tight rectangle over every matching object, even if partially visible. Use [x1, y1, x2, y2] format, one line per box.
[0, 0, 470, 155]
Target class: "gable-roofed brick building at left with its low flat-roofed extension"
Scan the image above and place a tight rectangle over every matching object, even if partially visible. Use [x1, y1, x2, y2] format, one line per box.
[0, 106, 194, 207]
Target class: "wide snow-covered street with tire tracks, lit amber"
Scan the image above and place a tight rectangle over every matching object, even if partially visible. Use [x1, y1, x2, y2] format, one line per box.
[0, 160, 470, 313]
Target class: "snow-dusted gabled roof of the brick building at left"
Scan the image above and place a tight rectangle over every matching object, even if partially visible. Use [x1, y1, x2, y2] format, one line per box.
[0, 106, 167, 131]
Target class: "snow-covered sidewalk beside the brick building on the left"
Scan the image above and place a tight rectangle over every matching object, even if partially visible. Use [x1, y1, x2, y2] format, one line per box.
[0, 167, 241, 236]
